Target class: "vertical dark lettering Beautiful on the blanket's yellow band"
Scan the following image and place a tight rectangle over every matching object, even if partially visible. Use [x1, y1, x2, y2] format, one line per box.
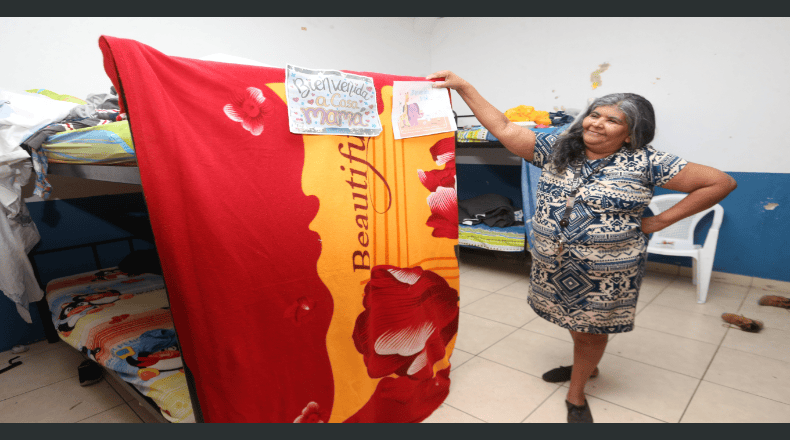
[338, 138, 392, 272]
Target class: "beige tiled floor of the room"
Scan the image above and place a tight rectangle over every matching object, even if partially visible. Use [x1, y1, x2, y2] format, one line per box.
[0, 254, 790, 423]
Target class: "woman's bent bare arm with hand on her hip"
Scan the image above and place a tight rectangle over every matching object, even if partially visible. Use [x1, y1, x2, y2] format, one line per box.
[642, 162, 738, 234]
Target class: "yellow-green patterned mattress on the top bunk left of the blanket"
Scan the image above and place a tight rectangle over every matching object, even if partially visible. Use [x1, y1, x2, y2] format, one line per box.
[41, 121, 136, 164]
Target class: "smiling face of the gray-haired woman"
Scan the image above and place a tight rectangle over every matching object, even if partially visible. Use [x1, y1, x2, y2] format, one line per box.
[582, 105, 631, 159]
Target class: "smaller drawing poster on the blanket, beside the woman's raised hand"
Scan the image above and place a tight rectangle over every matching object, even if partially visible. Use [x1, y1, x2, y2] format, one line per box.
[392, 81, 457, 139]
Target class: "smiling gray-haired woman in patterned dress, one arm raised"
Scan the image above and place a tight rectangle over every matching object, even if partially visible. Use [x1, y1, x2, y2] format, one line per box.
[426, 70, 737, 423]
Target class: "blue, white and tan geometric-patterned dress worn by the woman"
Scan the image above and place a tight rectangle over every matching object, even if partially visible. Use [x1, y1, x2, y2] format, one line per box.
[528, 133, 687, 333]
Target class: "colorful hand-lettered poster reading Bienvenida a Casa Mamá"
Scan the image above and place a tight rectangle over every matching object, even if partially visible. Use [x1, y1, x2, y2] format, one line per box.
[285, 64, 381, 137]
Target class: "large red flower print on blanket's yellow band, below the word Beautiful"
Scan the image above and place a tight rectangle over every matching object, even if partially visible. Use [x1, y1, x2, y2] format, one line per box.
[353, 265, 458, 380]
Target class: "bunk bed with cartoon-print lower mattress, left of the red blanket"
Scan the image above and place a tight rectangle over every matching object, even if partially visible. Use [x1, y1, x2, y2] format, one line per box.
[24, 120, 195, 423]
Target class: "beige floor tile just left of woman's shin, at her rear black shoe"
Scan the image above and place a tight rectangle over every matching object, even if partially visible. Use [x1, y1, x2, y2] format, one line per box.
[479, 330, 573, 377]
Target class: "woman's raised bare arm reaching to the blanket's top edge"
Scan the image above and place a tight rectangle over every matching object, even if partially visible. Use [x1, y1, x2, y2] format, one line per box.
[425, 70, 535, 161]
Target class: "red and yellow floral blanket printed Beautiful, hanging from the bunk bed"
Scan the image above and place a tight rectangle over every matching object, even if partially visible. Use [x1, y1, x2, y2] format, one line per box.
[99, 37, 459, 422]
